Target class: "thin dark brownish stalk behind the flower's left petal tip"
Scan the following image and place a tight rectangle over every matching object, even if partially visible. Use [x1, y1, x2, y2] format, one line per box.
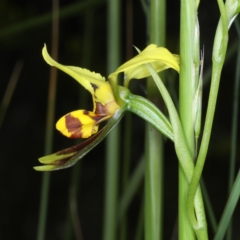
[37, 0, 59, 240]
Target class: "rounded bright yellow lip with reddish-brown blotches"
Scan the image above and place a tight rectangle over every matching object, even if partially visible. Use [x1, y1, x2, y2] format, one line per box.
[56, 110, 110, 138]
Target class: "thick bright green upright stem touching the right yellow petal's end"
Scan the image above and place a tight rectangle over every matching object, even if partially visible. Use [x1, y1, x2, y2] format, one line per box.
[178, 0, 196, 240]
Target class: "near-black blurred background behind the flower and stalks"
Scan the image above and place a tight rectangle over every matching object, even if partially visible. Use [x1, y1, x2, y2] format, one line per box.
[0, 0, 240, 240]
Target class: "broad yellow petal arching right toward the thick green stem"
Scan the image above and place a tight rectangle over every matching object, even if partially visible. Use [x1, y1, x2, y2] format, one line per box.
[109, 44, 180, 80]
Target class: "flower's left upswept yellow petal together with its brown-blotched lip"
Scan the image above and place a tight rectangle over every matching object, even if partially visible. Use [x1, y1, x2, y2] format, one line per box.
[42, 45, 120, 138]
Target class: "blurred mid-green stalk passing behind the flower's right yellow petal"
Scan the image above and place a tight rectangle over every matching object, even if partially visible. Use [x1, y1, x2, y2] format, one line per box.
[144, 0, 166, 240]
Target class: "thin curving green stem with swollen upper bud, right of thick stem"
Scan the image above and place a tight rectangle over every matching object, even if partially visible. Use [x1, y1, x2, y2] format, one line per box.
[187, 0, 228, 238]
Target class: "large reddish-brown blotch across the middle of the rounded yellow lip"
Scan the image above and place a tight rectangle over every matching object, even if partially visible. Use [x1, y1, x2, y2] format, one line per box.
[65, 113, 82, 138]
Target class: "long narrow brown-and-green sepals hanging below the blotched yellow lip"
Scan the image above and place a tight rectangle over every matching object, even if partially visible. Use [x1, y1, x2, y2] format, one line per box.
[34, 108, 126, 171]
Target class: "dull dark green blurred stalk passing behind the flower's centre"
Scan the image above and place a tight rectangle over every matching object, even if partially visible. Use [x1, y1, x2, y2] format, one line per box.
[103, 0, 120, 240]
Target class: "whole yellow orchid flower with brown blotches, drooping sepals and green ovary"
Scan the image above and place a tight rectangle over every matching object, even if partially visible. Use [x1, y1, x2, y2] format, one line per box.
[34, 44, 179, 171]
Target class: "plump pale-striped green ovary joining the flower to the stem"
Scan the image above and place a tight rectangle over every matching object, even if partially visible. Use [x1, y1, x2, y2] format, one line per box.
[127, 94, 174, 141]
